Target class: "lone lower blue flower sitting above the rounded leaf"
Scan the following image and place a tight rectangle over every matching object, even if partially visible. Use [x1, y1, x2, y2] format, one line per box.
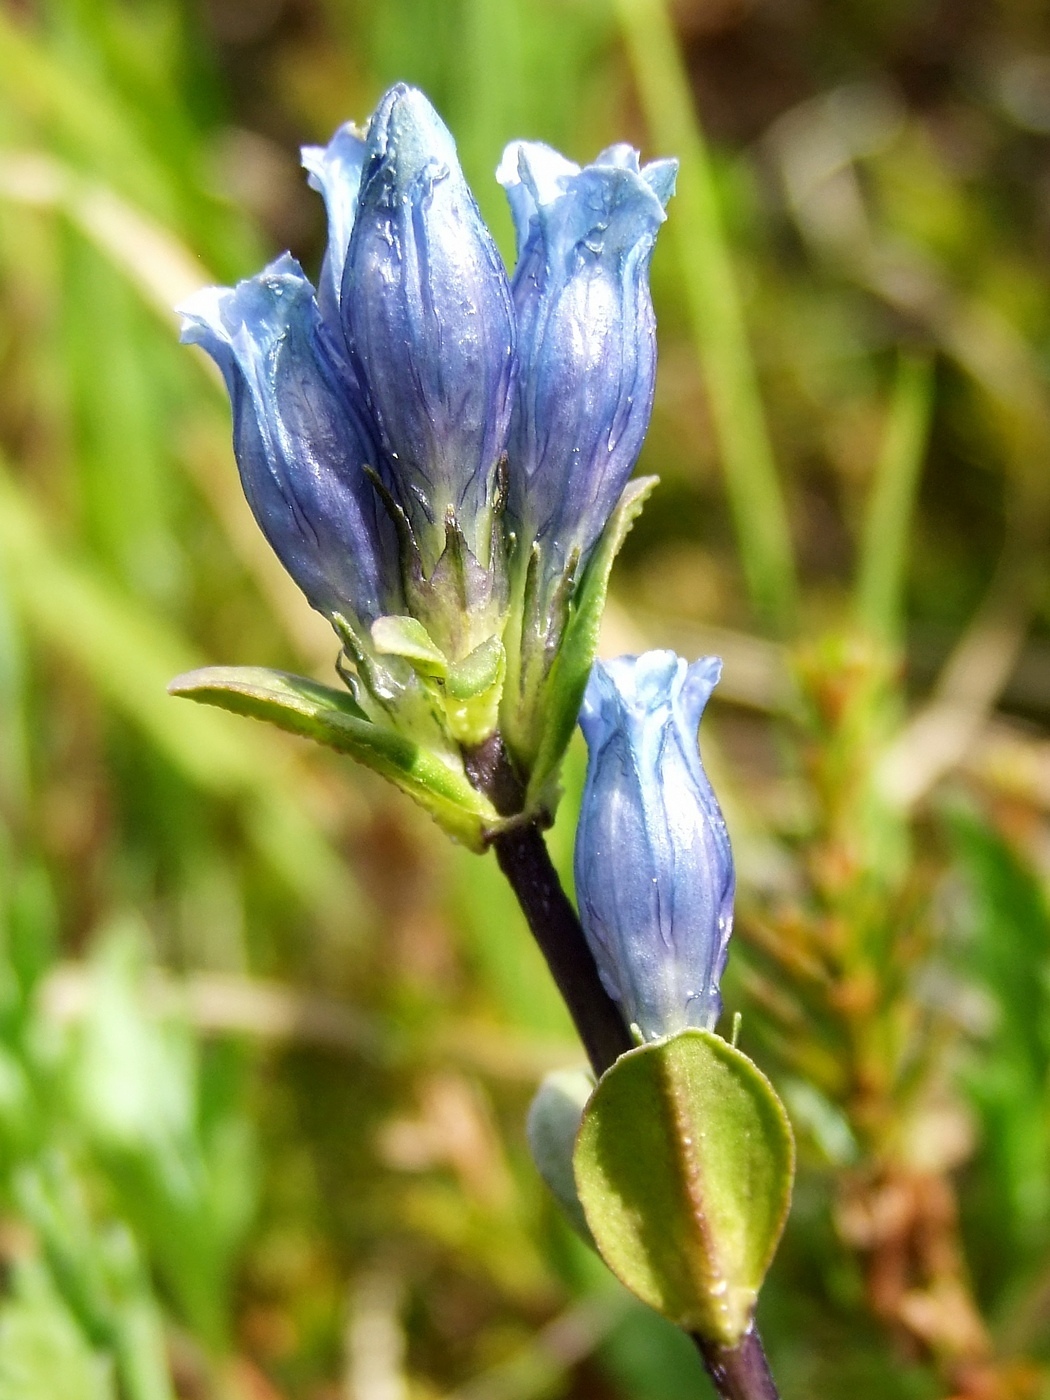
[575, 651, 734, 1039]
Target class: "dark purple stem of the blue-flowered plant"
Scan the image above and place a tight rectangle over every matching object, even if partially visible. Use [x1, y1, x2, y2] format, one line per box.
[466, 735, 778, 1400]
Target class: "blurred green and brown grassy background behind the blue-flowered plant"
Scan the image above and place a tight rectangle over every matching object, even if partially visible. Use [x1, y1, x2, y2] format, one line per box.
[0, 0, 1050, 1400]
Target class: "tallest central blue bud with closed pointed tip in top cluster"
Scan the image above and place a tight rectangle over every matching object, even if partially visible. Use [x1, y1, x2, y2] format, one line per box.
[342, 85, 514, 563]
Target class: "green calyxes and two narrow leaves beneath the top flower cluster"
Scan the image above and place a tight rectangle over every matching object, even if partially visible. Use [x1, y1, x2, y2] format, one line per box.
[169, 476, 657, 851]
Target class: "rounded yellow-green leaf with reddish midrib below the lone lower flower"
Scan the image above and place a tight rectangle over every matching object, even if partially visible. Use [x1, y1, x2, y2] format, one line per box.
[574, 1030, 795, 1347]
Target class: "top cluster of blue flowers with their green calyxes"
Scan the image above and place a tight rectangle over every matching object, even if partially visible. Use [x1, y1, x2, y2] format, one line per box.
[181, 84, 676, 817]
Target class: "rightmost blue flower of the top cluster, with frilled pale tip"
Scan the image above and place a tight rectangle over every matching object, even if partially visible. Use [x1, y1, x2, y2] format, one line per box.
[497, 141, 678, 580]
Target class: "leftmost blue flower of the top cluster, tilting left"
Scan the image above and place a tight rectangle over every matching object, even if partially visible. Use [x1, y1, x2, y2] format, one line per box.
[179, 255, 399, 623]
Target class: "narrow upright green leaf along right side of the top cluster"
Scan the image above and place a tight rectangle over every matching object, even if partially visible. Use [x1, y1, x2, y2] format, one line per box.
[526, 476, 659, 811]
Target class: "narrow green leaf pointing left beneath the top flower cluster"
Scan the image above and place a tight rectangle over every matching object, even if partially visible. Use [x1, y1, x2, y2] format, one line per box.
[168, 666, 500, 851]
